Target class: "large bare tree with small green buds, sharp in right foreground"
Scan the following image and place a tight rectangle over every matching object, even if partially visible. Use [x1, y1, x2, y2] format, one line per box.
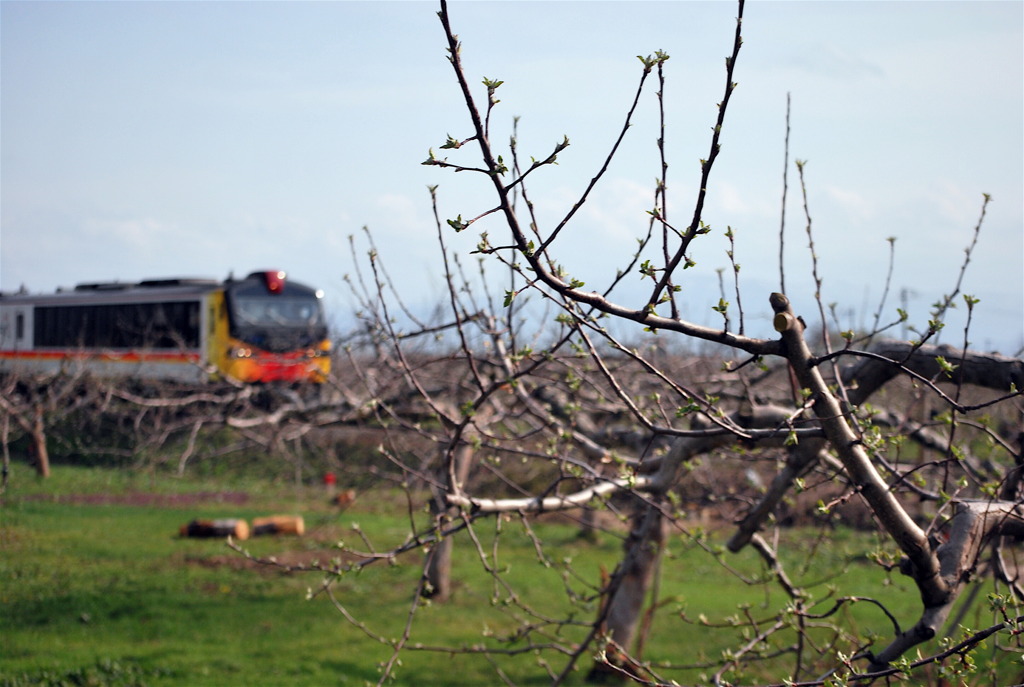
[280, 2, 1024, 684]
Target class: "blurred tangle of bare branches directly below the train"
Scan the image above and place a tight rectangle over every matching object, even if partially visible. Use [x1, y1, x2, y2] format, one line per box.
[0, 360, 383, 491]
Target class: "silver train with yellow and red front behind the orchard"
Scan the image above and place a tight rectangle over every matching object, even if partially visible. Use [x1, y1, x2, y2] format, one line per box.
[0, 270, 331, 384]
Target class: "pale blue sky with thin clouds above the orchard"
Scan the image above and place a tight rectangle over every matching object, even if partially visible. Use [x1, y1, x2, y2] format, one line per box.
[0, 0, 1024, 354]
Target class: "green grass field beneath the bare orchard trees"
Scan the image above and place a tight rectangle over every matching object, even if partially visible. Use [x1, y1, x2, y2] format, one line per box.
[0, 465, 1007, 687]
